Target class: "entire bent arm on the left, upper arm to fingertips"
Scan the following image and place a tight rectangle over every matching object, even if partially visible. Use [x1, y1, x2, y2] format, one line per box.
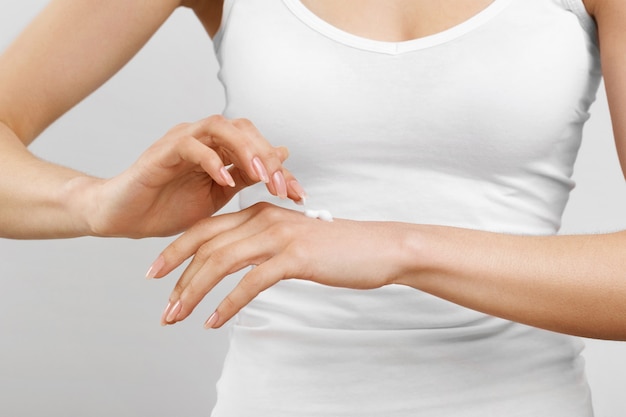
[0, 0, 303, 239]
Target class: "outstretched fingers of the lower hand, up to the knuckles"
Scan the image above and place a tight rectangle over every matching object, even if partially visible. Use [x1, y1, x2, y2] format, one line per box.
[156, 203, 302, 325]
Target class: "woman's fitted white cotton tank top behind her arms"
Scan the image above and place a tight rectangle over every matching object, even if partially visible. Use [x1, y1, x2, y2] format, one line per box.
[208, 0, 601, 417]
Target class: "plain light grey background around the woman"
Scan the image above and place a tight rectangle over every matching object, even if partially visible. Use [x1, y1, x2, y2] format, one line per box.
[0, 0, 626, 417]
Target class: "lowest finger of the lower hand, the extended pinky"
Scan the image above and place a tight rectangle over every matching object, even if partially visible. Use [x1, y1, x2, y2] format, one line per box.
[204, 256, 287, 329]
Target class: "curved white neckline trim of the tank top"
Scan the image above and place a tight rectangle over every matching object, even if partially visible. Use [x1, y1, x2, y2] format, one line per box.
[283, 0, 511, 54]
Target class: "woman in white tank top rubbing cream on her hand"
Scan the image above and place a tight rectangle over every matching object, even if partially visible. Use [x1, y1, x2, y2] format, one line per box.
[0, 0, 626, 416]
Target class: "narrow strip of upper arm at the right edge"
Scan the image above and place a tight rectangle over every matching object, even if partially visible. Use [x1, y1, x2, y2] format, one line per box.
[586, 0, 626, 176]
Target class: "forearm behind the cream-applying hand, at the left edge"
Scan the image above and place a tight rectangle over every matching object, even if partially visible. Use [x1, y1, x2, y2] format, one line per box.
[0, 123, 98, 239]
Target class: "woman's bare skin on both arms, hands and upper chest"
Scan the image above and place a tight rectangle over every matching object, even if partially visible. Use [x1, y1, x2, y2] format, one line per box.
[0, 0, 626, 340]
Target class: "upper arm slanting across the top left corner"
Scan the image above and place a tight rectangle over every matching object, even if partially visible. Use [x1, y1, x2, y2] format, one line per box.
[0, 0, 180, 144]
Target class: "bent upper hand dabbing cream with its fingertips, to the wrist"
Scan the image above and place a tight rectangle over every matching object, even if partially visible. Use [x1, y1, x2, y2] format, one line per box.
[76, 116, 305, 238]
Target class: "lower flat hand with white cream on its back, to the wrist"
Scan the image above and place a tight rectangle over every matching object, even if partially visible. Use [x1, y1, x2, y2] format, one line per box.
[149, 203, 406, 328]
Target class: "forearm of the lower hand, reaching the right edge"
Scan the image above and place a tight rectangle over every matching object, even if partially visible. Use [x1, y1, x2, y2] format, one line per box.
[398, 226, 626, 340]
